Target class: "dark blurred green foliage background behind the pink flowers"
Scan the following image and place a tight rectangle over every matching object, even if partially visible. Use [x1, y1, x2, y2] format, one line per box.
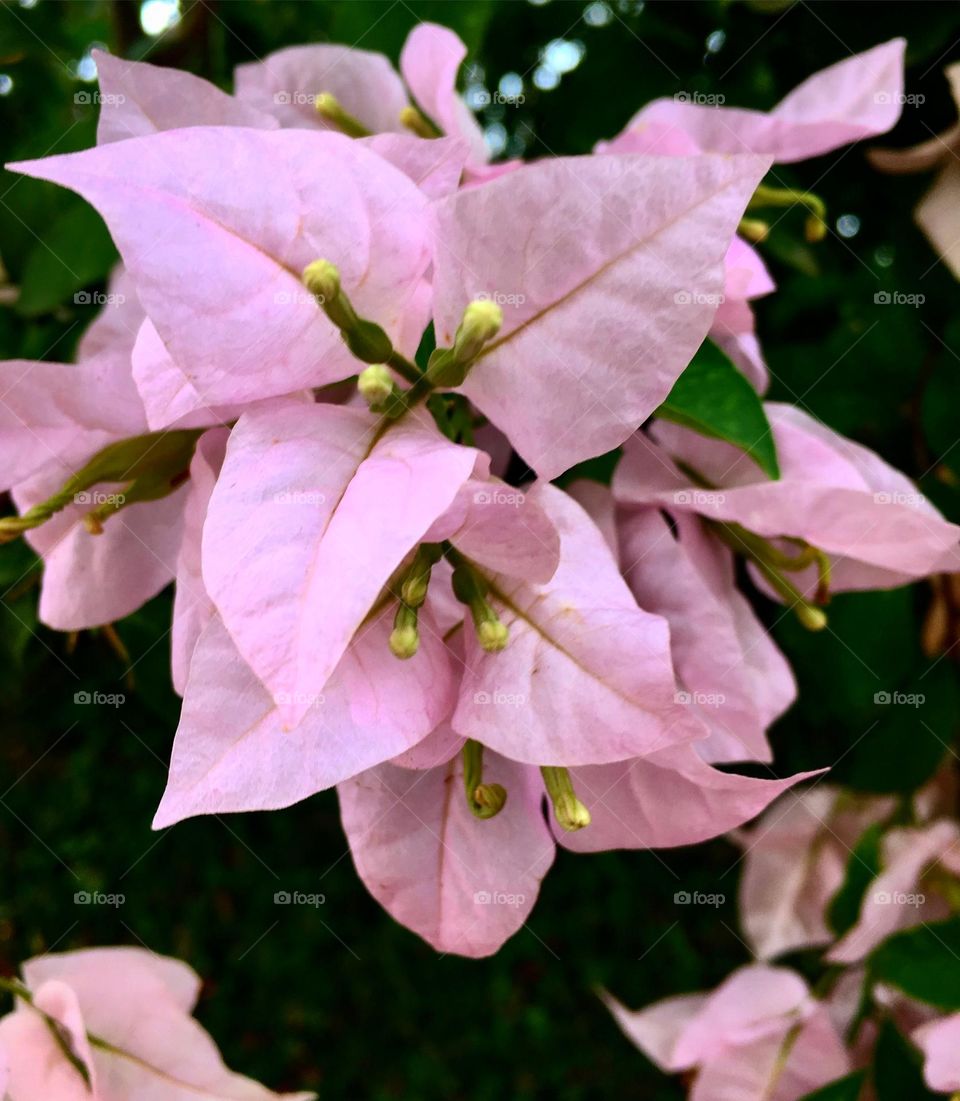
[0, 0, 960, 1101]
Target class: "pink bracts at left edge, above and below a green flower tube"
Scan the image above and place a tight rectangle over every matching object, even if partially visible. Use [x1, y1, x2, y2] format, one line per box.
[0, 277, 192, 631]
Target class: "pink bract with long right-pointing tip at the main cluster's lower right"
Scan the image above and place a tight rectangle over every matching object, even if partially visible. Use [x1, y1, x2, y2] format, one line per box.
[558, 744, 819, 852]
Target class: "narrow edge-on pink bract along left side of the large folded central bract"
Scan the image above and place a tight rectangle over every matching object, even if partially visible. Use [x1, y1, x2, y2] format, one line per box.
[170, 428, 230, 696]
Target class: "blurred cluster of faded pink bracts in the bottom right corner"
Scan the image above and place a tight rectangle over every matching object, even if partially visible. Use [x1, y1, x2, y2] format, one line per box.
[608, 782, 960, 1101]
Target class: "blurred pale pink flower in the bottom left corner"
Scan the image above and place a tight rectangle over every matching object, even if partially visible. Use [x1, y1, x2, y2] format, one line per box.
[0, 948, 315, 1101]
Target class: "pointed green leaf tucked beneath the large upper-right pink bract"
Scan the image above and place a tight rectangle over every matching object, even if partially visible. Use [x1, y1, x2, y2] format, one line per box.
[656, 340, 779, 478]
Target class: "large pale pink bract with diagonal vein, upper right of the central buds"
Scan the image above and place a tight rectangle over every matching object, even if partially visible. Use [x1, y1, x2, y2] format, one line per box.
[434, 150, 770, 479]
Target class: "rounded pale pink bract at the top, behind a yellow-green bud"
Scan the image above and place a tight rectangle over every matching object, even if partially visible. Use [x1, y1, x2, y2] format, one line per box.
[234, 45, 407, 133]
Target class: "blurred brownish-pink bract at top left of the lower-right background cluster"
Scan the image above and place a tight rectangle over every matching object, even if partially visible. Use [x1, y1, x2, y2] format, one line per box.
[738, 784, 895, 959]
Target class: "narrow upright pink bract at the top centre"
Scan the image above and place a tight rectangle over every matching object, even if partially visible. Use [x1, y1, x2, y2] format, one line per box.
[400, 23, 490, 164]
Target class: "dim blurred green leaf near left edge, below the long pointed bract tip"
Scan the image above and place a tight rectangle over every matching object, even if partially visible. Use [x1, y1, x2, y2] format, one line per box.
[17, 201, 117, 317]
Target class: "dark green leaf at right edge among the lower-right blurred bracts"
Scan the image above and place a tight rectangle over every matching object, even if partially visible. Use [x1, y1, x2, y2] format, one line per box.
[868, 917, 960, 1011]
